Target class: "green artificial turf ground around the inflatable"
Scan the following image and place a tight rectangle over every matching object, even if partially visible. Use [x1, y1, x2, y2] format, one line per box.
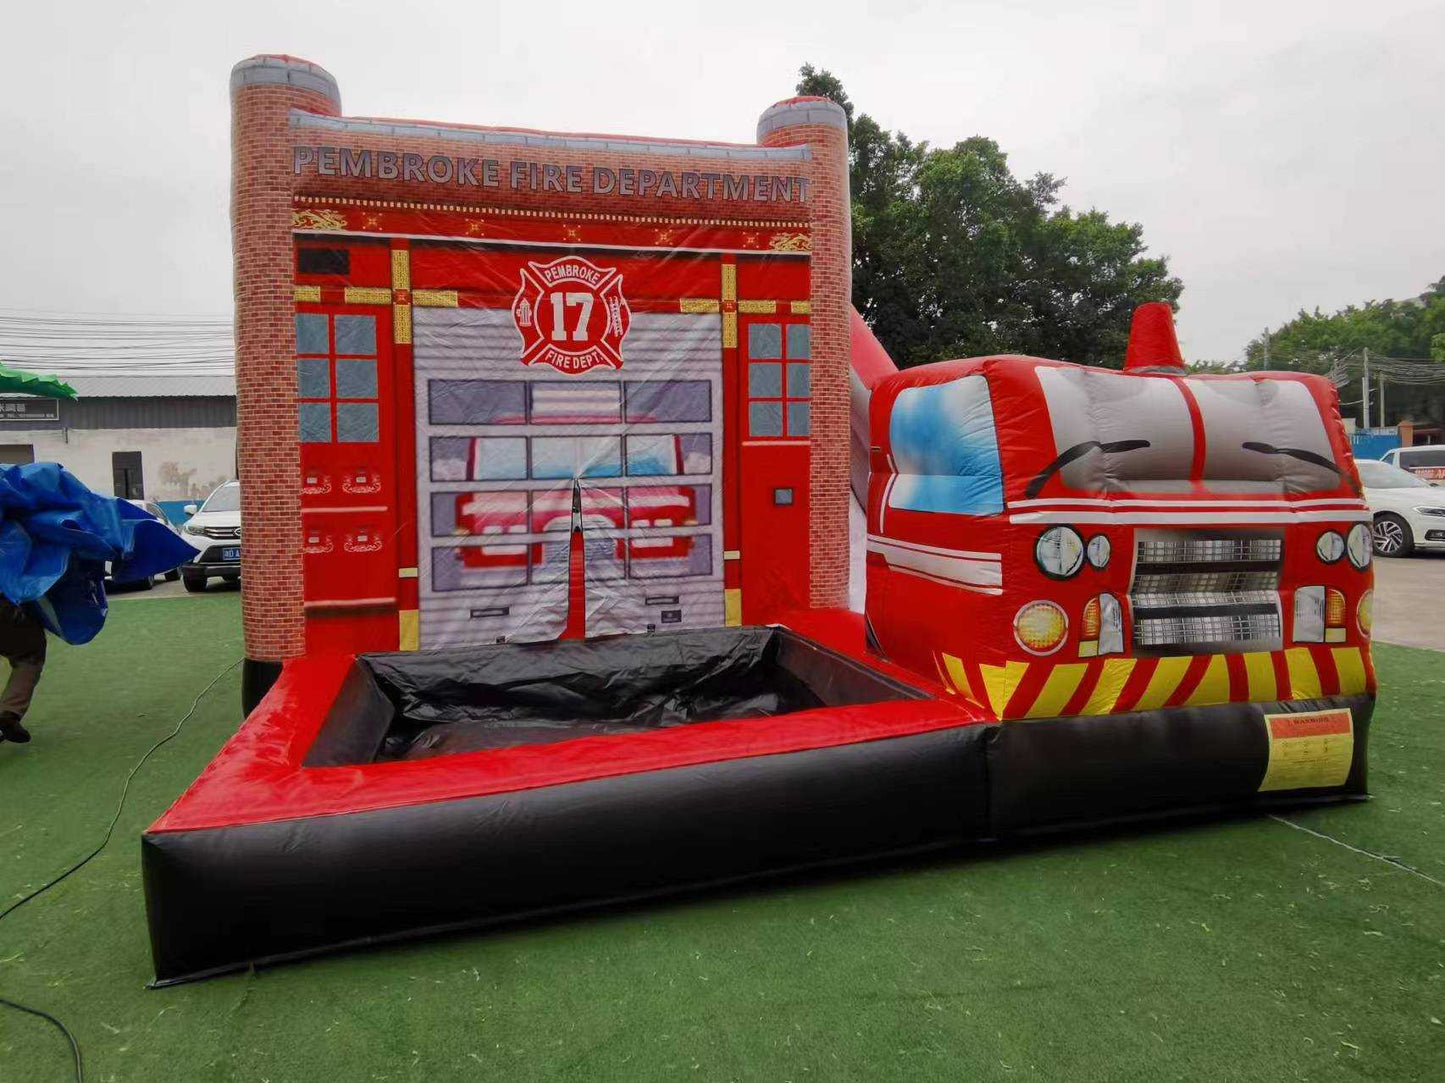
[0, 593, 1445, 1083]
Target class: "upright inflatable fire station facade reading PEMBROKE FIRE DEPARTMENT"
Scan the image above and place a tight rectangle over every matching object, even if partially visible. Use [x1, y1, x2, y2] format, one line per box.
[231, 56, 850, 706]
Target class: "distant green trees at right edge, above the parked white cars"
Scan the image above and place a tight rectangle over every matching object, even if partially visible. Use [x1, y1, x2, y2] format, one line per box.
[1244, 278, 1445, 425]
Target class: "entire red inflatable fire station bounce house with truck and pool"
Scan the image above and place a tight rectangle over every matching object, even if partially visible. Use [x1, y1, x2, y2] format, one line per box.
[143, 56, 1374, 982]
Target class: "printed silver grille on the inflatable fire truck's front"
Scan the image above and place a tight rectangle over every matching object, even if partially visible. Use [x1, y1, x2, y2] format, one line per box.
[1129, 529, 1285, 654]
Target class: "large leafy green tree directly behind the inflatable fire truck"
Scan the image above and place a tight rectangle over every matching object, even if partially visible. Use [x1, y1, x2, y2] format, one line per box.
[798, 64, 1183, 367]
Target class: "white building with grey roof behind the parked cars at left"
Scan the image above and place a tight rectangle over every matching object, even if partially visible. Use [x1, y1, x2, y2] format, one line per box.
[0, 374, 236, 521]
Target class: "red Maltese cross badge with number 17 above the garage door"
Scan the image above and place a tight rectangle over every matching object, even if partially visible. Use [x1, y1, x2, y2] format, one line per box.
[512, 256, 631, 376]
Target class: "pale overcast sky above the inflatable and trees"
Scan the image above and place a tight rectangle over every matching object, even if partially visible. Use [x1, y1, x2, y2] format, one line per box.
[0, 0, 1445, 360]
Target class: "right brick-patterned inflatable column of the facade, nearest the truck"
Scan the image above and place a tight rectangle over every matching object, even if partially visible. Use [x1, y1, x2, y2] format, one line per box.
[757, 97, 853, 606]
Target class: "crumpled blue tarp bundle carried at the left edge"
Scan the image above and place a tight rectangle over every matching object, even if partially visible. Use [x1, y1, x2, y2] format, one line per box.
[0, 463, 195, 643]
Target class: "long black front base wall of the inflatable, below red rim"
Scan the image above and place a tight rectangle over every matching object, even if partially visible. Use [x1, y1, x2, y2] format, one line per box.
[142, 695, 1374, 985]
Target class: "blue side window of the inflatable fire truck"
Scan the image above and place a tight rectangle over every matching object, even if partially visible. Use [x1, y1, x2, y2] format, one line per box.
[889, 376, 1003, 515]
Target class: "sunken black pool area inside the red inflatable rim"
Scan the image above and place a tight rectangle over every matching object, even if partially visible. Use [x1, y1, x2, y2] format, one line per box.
[306, 628, 923, 766]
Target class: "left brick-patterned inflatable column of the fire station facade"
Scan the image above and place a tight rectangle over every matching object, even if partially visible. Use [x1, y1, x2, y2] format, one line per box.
[231, 56, 341, 713]
